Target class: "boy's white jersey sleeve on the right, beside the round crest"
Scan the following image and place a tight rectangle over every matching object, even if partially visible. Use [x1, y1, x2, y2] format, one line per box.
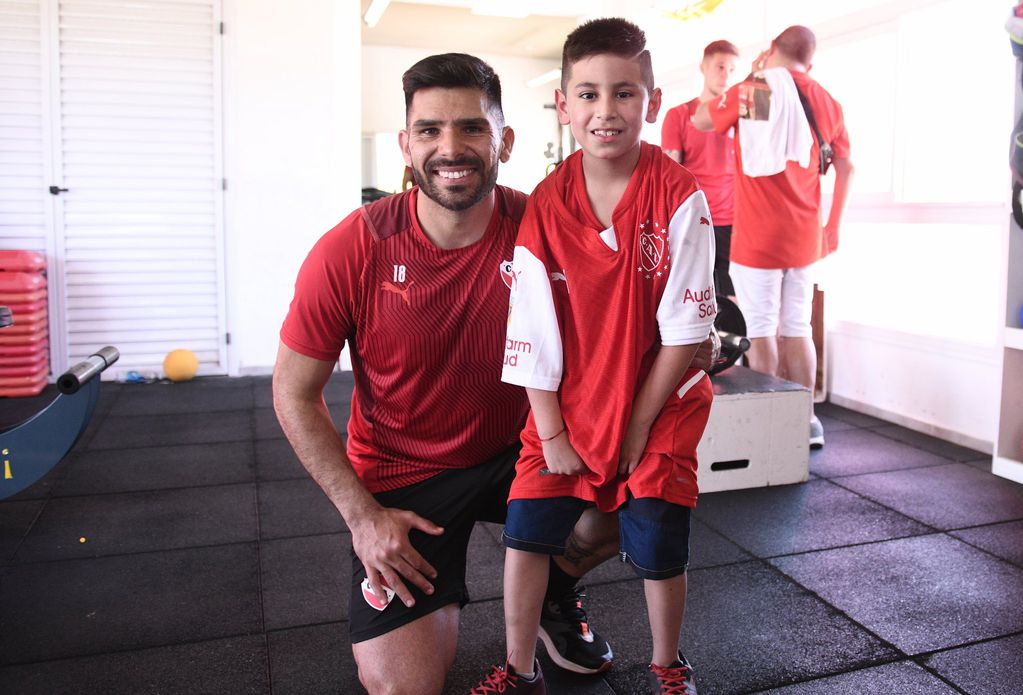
[657, 190, 717, 345]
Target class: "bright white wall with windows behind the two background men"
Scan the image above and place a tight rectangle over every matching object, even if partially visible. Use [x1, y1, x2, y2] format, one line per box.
[643, 0, 1014, 450]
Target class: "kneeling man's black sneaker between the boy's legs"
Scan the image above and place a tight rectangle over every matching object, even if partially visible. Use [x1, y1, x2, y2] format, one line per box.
[539, 587, 614, 674]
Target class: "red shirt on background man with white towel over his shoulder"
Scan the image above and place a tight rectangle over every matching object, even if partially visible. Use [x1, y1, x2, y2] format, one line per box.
[707, 70, 849, 268]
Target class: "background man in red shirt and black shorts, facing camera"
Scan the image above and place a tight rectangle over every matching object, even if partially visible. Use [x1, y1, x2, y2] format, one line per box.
[661, 39, 739, 297]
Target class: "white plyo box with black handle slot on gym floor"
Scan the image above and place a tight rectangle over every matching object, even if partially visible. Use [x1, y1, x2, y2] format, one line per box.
[697, 366, 810, 492]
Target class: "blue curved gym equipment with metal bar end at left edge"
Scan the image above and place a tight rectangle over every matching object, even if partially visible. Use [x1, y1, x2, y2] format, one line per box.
[0, 345, 121, 499]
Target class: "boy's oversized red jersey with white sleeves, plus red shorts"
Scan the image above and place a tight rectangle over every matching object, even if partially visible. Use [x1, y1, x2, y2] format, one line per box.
[501, 142, 716, 511]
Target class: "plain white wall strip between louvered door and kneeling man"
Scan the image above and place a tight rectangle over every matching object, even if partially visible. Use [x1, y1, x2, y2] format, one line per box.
[224, 0, 361, 375]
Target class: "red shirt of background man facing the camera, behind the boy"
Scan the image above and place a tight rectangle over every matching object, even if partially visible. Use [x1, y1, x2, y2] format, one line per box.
[661, 98, 736, 226]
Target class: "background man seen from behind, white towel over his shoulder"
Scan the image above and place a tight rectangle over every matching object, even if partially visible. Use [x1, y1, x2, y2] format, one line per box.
[693, 26, 853, 447]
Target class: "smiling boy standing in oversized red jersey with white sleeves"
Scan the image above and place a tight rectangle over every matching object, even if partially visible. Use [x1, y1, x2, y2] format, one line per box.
[473, 18, 716, 694]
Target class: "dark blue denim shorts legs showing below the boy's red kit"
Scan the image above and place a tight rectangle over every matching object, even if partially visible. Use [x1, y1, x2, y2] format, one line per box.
[502, 495, 692, 579]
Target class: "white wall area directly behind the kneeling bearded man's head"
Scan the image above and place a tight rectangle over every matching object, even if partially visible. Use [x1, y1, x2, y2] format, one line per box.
[362, 46, 568, 198]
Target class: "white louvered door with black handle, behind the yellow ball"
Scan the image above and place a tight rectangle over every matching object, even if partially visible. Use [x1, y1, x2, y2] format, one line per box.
[0, 0, 227, 374]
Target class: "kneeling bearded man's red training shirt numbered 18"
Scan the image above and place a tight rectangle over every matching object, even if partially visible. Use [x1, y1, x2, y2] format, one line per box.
[280, 186, 529, 492]
